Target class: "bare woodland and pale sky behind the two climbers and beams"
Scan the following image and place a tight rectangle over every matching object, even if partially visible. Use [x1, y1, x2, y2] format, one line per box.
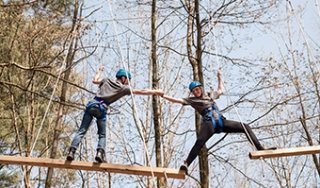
[0, 0, 320, 188]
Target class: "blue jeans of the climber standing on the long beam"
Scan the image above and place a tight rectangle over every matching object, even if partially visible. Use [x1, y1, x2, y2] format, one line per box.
[71, 100, 107, 150]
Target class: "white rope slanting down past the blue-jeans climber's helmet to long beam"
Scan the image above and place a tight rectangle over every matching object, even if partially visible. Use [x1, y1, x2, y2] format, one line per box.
[108, 0, 156, 187]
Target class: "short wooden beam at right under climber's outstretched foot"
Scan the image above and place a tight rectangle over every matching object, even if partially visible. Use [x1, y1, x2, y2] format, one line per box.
[249, 146, 320, 159]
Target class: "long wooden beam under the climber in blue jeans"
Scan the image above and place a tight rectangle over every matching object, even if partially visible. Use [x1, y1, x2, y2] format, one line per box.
[0, 155, 185, 179]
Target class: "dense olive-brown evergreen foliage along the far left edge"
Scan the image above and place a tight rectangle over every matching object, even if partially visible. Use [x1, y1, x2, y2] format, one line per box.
[0, 4, 63, 150]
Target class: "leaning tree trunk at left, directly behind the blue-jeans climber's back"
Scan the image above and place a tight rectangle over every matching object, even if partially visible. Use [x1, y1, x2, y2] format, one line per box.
[45, 1, 79, 188]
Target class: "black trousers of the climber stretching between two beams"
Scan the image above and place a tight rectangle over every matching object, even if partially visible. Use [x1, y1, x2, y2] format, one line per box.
[186, 119, 264, 165]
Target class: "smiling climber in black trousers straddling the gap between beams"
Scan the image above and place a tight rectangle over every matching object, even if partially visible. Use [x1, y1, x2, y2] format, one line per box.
[162, 70, 275, 173]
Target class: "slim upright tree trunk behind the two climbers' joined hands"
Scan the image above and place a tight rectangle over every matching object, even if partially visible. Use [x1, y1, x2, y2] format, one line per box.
[151, 0, 166, 188]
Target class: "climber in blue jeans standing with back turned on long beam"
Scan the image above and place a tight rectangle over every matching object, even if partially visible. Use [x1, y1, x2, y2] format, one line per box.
[67, 66, 163, 163]
